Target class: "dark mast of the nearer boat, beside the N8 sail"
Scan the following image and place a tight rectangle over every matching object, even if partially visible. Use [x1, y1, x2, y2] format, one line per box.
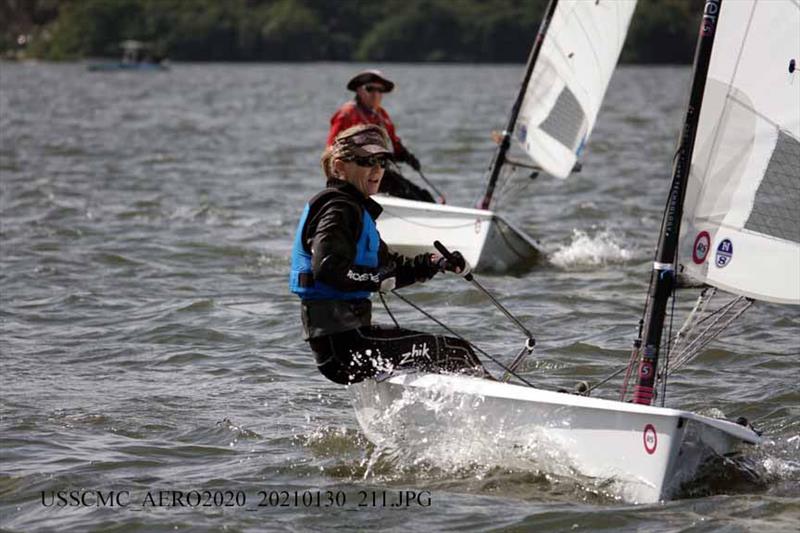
[633, 0, 722, 405]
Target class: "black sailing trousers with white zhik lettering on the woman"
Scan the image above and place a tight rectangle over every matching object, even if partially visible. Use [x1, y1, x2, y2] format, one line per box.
[308, 325, 488, 385]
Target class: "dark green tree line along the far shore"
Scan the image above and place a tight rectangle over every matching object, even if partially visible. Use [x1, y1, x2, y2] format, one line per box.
[0, 0, 703, 63]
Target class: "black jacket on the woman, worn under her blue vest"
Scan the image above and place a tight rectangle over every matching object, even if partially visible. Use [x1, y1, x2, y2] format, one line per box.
[302, 179, 439, 339]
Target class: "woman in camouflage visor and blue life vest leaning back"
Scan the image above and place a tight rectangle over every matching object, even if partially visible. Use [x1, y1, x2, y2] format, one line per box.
[289, 124, 486, 384]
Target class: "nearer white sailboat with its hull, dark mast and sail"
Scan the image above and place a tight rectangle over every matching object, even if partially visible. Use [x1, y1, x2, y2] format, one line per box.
[351, 0, 800, 503]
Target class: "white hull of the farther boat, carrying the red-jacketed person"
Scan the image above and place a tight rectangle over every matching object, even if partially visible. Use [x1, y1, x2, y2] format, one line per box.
[372, 194, 543, 272]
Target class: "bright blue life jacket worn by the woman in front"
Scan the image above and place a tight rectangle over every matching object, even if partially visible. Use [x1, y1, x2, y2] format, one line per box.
[289, 198, 381, 300]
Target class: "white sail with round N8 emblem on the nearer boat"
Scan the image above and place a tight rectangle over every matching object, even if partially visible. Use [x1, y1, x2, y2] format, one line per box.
[679, 0, 800, 304]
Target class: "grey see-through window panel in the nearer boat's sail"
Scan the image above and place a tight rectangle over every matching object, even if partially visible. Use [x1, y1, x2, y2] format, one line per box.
[744, 131, 800, 242]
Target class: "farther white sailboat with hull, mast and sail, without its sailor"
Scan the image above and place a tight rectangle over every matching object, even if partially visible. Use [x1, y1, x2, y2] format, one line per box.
[374, 0, 636, 271]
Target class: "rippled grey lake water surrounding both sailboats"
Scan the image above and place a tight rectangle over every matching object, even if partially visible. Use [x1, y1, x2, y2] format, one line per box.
[0, 63, 800, 531]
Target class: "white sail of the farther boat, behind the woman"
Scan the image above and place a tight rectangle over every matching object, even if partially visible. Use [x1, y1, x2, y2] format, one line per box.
[514, 0, 636, 178]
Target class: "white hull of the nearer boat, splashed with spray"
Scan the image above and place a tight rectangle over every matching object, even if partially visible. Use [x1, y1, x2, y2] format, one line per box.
[350, 373, 760, 503]
